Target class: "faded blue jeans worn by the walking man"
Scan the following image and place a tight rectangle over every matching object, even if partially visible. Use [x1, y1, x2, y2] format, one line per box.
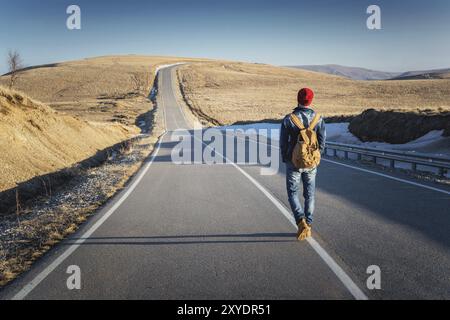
[286, 161, 317, 224]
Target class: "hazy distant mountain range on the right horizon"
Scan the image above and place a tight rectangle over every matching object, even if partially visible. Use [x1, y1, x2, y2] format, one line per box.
[289, 64, 450, 80]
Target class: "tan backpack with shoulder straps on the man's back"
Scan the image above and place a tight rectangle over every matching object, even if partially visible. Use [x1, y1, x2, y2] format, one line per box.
[291, 113, 320, 169]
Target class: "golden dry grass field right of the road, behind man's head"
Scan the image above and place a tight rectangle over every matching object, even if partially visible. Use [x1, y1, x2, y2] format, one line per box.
[178, 61, 450, 124]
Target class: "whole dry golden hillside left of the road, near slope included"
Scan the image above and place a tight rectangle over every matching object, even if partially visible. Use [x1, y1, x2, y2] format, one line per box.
[0, 55, 202, 191]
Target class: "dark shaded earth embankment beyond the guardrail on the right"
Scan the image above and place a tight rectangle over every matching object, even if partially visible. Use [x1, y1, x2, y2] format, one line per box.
[349, 109, 450, 144]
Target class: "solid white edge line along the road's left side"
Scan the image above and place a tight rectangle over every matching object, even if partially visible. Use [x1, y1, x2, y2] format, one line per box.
[12, 133, 166, 300]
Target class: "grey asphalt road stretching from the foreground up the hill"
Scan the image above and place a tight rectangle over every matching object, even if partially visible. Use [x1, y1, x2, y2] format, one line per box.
[0, 68, 450, 299]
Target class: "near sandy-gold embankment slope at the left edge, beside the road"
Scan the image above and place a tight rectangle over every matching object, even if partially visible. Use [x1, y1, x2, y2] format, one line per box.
[0, 87, 133, 191]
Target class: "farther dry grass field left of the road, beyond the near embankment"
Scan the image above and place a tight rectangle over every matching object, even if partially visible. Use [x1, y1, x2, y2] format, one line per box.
[0, 55, 203, 126]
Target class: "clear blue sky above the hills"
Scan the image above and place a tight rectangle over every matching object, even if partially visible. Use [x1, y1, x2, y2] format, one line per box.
[0, 0, 450, 72]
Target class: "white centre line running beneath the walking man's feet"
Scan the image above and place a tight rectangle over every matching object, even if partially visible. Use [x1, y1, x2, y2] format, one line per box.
[194, 136, 369, 300]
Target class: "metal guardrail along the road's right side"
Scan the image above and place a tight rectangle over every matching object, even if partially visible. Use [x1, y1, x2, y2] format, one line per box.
[325, 142, 450, 177]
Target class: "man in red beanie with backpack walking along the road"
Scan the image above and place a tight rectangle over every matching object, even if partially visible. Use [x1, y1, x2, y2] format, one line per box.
[280, 88, 326, 240]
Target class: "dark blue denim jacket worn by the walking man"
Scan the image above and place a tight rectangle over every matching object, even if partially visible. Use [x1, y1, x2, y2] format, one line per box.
[280, 106, 326, 162]
